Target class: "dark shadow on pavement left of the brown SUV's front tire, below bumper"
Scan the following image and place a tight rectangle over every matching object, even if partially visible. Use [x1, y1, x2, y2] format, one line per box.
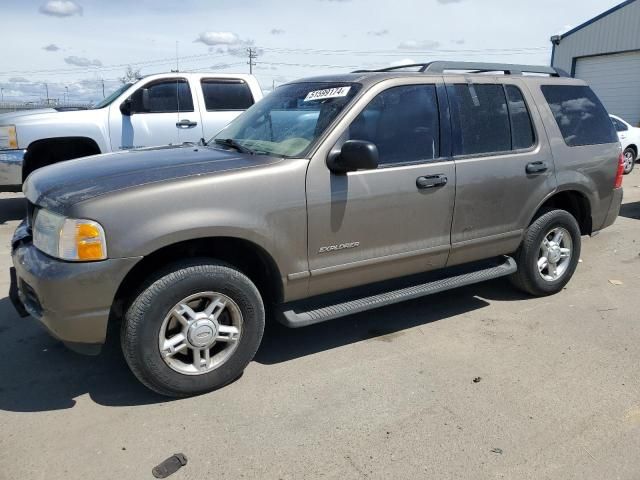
[0, 298, 168, 412]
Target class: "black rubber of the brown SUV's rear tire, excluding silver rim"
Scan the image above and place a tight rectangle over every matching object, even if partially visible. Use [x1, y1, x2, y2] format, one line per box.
[510, 210, 581, 296]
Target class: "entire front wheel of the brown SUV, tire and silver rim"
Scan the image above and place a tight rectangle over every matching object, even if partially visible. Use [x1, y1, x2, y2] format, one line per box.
[121, 260, 265, 397]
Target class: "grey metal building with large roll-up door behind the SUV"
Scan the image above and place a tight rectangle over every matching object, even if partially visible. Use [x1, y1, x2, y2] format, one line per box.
[551, 0, 640, 126]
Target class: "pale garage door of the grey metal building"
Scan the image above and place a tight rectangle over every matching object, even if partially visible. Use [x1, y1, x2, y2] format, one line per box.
[575, 50, 640, 125]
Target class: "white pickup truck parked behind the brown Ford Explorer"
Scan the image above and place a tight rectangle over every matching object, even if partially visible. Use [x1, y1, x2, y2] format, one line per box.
[0, 73, 262, 191]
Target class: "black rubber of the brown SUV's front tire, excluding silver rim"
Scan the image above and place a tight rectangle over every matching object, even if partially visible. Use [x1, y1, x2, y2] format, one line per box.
[121, 259, 265, 397]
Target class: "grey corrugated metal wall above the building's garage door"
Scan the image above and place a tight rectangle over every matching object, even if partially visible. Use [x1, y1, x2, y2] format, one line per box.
[553, 0, 640, 73]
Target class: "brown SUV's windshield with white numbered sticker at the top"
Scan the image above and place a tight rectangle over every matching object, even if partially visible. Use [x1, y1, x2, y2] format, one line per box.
[214, 82, 361, 157]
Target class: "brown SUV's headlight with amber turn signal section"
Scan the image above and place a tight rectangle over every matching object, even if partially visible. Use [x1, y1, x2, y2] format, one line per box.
[33, 209, 107, 262]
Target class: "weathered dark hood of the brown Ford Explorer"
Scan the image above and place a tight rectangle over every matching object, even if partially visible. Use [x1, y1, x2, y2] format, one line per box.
[23, 145, 282, 210]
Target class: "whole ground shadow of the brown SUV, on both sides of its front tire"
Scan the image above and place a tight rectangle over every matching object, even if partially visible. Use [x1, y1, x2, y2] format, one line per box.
[0, 280, 527, 412]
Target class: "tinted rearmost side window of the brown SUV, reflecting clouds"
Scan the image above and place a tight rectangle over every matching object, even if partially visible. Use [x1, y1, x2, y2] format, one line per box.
[542, 85, 618, 147]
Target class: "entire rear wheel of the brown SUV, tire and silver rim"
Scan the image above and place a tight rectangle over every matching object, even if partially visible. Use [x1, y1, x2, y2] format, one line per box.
[511, 210, 581, 296]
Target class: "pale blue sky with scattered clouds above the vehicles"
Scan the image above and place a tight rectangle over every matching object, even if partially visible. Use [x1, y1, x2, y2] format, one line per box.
[0, 0, 621, 102]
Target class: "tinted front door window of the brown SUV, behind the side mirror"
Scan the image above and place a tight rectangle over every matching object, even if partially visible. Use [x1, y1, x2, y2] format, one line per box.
[349, 85, 440, 164]
